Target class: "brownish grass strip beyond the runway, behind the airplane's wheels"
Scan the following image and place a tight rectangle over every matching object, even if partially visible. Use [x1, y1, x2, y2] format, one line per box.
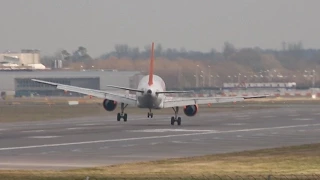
[0, 95, 320, 122]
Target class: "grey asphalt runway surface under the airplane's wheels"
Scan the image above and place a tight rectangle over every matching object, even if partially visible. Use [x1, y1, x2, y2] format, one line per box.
[0, 105, 320, 169]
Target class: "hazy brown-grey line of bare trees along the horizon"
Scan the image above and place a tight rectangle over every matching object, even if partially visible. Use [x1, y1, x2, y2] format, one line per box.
[42, 42, 320, 86]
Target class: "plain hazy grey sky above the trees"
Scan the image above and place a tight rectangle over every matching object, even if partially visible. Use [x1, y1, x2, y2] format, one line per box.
[0, 0, 320, 56]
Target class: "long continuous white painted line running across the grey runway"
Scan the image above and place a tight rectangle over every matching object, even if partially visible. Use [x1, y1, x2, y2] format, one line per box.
[0, 123, 320, 151]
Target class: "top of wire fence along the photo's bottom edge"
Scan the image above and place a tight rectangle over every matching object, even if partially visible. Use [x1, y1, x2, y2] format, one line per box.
[77, 174, 320, 180]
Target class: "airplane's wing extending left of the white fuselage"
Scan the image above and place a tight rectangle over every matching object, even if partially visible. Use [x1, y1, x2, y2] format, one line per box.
[31, 79, 137, 106]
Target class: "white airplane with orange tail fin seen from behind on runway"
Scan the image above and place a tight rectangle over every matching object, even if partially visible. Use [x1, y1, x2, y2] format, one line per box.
[31, 42, 267, 126]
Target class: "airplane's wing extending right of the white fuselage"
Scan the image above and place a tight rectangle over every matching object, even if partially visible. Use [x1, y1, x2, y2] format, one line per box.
[163, 95, 267, 108]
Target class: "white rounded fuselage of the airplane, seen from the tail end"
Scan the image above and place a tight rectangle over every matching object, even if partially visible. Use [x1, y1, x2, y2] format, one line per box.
[136, 75, 166, 109]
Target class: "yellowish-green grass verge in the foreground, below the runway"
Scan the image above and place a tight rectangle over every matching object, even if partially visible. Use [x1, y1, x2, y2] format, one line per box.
[0, 144, 320, 180]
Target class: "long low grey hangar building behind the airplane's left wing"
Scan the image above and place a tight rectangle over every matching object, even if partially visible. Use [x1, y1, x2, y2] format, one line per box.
[0, 70, 142, 97]
